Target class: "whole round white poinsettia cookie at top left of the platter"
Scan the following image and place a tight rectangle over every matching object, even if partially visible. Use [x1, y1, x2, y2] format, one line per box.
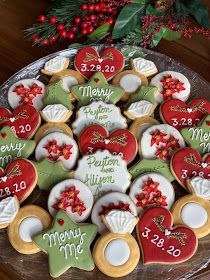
[8, 79, 46, 111]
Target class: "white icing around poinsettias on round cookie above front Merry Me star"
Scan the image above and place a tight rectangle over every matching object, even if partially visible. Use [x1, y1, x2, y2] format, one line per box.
[48, 179, 93, 223]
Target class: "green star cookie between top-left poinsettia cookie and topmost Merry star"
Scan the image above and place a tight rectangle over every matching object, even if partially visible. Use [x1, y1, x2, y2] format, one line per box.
[44, 80, 73, 110]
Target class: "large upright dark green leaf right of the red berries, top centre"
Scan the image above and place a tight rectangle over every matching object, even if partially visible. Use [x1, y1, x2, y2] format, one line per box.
[112, 3, 145, 39]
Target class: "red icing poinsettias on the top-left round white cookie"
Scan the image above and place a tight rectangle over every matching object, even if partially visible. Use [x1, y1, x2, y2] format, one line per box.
[13, 83, 42, 105]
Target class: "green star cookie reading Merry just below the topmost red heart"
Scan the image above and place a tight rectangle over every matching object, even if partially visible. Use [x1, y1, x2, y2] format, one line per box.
[71, 72, 124, 107]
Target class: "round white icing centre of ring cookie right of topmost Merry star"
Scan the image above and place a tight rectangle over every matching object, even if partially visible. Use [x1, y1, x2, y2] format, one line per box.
[120, 74, 141, 93]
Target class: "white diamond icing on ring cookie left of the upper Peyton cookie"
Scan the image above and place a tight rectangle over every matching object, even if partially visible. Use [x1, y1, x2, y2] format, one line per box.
[42, 104, 69, 122]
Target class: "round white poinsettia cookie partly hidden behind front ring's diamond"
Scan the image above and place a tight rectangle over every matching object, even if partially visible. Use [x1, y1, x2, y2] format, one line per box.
[91, 192, 137, 234]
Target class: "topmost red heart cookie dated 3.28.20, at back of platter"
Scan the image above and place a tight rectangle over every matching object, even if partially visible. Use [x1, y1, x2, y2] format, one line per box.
[74, 47, 124, 80]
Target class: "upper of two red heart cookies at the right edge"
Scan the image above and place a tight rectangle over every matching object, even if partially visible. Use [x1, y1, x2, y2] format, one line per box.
[160, 98, 210, 129]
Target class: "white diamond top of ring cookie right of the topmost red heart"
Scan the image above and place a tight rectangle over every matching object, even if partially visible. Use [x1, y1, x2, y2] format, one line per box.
[131, 57, 158, 77]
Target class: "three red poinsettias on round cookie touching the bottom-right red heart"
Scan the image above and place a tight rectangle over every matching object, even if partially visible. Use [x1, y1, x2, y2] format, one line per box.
[135, 178, 168, 209]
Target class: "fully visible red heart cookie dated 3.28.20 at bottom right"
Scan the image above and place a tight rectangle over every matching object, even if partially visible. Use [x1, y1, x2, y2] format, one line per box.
[137, 207, 198, 264]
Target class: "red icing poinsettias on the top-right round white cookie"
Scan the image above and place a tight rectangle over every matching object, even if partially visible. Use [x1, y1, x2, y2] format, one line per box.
[160, 75, 185, 99]
